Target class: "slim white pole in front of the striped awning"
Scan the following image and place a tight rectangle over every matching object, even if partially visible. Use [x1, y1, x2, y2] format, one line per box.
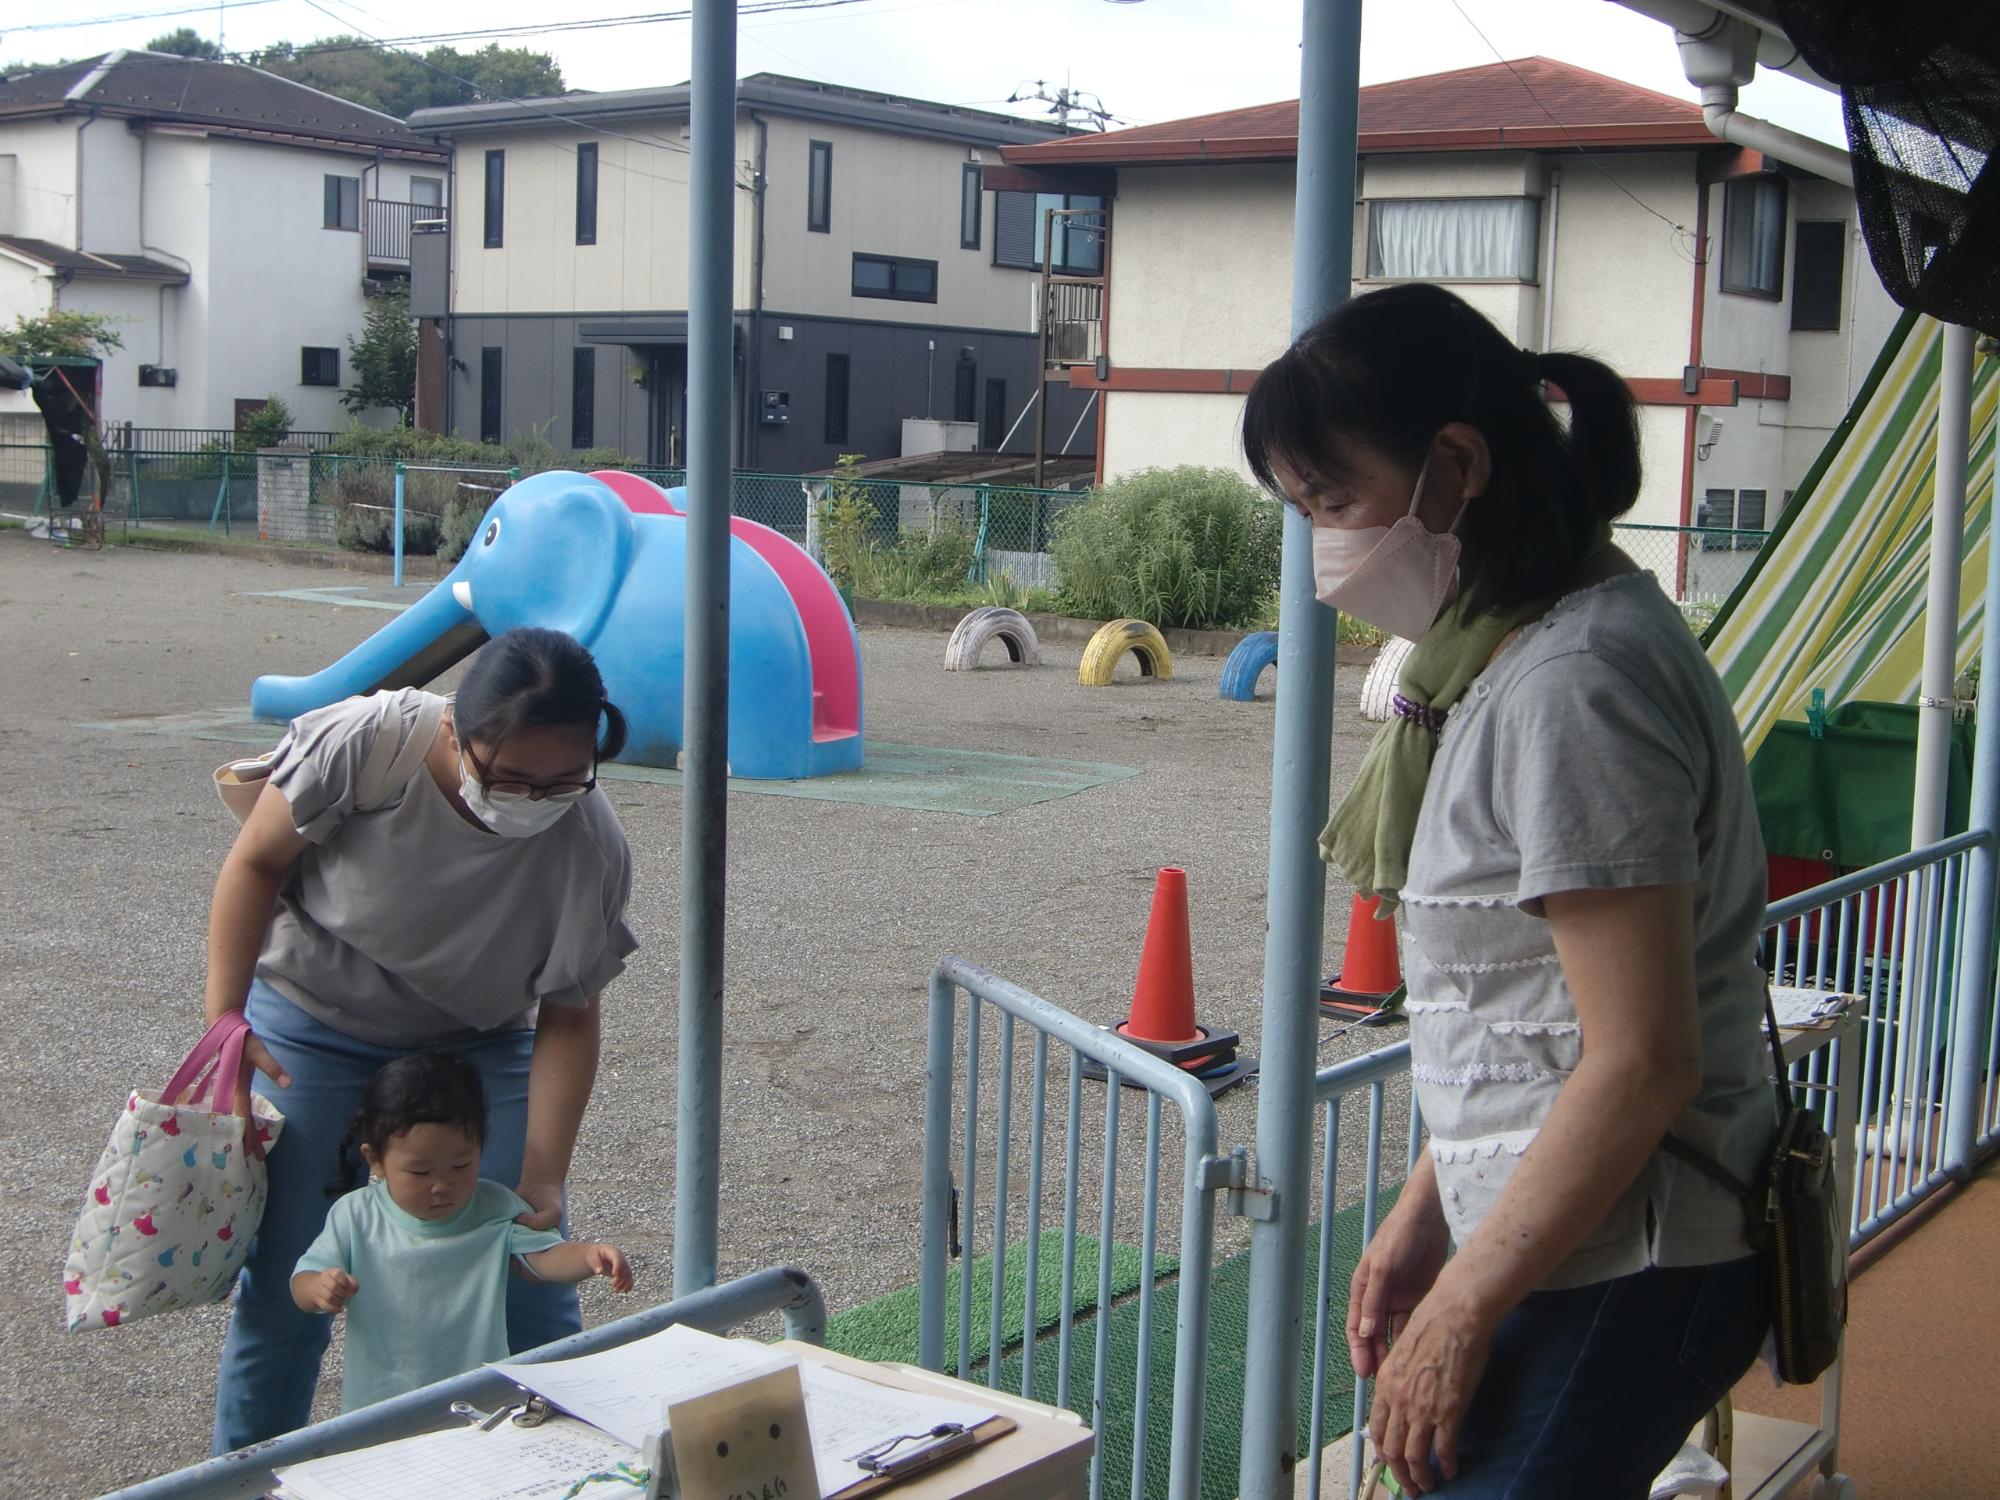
[1910, 324, 1972, 848]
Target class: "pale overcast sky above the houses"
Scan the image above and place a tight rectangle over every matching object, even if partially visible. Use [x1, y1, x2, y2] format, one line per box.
[0, 0, 1842, 142]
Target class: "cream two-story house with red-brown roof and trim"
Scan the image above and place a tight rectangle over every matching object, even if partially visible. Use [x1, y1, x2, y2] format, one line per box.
[986, 58, 1896, 548]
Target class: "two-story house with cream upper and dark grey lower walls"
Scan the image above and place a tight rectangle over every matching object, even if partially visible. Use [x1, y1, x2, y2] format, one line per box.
[410, 74, 1096, 472]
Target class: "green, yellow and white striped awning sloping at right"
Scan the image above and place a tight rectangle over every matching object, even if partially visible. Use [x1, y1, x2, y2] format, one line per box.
[1706, 314, 2000, 756]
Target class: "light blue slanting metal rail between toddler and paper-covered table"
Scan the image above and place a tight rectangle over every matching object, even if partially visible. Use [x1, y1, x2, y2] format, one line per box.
[104, 1266, 826, 1500]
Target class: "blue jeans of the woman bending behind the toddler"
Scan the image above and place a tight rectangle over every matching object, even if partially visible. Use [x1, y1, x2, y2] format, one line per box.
[214, 980, 584, 1454]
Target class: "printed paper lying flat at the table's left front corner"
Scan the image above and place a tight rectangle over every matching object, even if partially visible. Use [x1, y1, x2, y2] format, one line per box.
[278, 1418, 638, 1500]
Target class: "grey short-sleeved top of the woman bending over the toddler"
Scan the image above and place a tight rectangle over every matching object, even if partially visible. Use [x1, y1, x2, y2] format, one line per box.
[256, 688, 638, 1046]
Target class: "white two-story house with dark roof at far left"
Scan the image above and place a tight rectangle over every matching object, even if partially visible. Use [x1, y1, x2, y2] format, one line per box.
[0, 52, 448, 430]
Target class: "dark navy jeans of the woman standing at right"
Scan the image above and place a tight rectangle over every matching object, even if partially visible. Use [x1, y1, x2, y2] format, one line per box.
[1436, 1256, 1770, 1500]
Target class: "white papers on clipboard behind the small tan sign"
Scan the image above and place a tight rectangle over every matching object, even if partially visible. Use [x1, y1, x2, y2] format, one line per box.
[494, 1326, 994, 1496]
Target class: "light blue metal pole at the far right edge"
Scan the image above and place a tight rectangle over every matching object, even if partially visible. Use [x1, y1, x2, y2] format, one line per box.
[1944, 328, 2000, 1180]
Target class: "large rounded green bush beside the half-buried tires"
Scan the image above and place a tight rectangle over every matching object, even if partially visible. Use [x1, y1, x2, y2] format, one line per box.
[1050, 466, 1284, 630]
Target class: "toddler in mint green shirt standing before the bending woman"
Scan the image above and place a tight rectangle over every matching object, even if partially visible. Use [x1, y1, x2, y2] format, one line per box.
[292, 1054, 632, 1412]
